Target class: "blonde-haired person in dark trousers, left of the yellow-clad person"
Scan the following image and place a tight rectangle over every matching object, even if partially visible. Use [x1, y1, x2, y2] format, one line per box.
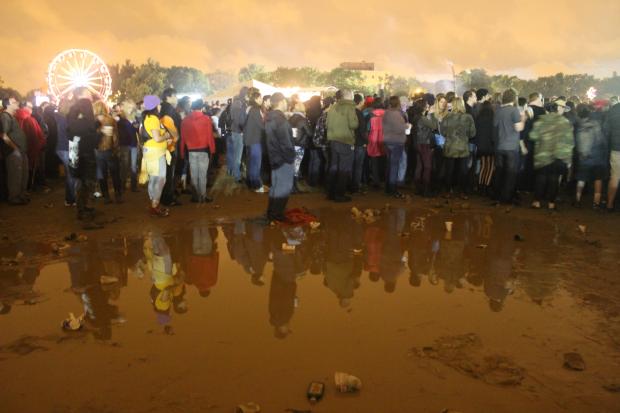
[93, 100, 123, 204]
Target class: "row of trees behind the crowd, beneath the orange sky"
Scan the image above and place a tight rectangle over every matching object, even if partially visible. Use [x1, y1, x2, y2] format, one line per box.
[0, 59, 620, 101]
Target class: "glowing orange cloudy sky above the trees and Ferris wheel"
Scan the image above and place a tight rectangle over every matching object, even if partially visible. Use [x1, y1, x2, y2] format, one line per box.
[0, 0, 620, 91]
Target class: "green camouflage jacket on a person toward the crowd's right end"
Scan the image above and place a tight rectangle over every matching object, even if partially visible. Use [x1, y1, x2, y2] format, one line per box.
[530, 113, 574, 169]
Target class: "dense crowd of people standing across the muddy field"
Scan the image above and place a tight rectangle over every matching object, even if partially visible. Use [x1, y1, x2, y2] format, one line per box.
[0, 83, 620, 227]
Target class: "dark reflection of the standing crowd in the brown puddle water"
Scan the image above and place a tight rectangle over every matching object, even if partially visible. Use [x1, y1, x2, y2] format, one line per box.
[0, 209, 568, 339]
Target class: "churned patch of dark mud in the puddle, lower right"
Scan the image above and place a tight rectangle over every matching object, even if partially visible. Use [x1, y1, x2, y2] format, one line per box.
[413, 333, 525, 386]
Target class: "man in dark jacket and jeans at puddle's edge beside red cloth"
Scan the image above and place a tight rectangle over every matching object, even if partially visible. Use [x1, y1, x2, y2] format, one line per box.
[265, 92, 295, 221]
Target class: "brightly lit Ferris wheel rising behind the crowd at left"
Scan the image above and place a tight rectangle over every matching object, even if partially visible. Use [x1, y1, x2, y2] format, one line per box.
[47, 49, 112, 100]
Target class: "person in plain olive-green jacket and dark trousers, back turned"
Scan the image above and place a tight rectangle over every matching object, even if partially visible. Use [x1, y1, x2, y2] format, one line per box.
[327, 90, 359, 202]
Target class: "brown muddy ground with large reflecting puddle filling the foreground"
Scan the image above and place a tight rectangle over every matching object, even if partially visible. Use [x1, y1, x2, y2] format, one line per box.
[0, 208, 620, 413]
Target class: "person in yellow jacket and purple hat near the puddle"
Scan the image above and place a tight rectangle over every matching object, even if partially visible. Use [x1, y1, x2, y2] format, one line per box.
[140, 95, 173, 217]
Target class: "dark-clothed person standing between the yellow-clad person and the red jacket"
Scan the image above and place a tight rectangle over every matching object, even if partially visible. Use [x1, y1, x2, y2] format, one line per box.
[159, 88, 181, 206]
